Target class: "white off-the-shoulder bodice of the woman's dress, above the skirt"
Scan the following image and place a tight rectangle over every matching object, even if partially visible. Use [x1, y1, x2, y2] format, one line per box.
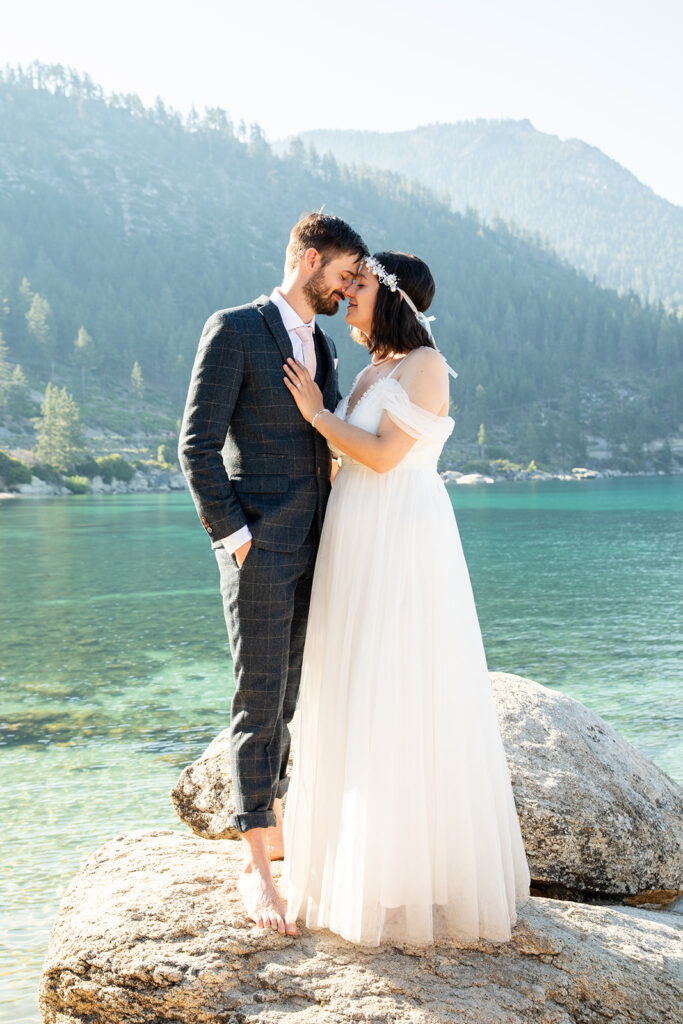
[332, 375, 455, 472]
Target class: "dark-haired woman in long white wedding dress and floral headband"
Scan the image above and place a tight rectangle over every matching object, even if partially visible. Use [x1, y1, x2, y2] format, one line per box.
[284, 252, 529, 945]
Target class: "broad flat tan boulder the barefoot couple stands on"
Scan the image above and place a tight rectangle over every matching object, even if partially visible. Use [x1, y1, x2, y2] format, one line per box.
[40, 831, 683, 1024]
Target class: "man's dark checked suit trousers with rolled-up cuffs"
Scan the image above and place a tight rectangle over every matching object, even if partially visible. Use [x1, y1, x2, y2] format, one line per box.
[215, 516, 318, 833]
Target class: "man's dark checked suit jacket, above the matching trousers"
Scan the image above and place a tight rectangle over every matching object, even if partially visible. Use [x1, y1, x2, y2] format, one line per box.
[178, 295, 339, 551]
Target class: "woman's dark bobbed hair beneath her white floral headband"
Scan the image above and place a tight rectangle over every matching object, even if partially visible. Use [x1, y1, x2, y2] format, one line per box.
[351, 252, 436, 358]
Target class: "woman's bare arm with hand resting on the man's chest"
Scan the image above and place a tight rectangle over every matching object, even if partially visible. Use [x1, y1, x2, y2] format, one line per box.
[285, 348, 449, 473]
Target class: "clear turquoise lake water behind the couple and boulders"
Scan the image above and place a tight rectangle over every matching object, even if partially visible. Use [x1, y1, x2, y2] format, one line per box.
[0, 477, 683, 1024]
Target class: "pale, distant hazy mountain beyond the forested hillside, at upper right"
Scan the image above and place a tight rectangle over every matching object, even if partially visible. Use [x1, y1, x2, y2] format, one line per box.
[292, 119, 683, 309]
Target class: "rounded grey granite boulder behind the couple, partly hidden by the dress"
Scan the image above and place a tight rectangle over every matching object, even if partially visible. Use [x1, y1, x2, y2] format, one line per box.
[171, 672, 683, 903]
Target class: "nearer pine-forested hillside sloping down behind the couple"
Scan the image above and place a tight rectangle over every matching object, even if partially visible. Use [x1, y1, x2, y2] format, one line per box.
[0, 66, 683, 466]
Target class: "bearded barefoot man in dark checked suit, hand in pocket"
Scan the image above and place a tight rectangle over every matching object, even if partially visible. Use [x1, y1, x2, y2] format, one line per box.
[178, 213, 368, 934]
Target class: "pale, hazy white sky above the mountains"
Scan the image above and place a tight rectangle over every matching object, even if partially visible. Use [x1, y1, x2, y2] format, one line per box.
[5, 0, 683, 205]
